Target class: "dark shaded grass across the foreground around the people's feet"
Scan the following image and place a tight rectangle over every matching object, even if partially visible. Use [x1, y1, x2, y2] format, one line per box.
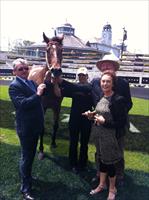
[0, 142, 149, 200]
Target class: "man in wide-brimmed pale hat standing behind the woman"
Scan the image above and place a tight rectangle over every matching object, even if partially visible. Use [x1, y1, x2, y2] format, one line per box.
[91, 54, 133, 185]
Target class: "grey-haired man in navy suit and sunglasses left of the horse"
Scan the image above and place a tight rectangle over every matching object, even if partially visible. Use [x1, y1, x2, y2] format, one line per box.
[9, 58, 45, 200]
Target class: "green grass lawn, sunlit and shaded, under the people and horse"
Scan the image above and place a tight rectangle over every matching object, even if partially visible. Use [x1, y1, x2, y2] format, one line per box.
[0, 86, 149, 200]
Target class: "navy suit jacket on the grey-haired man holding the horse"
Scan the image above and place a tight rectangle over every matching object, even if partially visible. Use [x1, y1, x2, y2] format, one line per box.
[9, 77, 44, 136]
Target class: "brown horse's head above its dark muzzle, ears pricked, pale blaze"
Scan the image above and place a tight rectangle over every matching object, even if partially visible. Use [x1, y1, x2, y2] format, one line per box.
[43, 33, 64, 69]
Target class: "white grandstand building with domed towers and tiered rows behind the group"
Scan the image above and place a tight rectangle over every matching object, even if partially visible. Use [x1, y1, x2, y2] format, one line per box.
[0, 23, 149, 85]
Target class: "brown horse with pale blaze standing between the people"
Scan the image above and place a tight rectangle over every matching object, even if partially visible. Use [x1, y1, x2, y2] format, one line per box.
[28, 33, 63, 159]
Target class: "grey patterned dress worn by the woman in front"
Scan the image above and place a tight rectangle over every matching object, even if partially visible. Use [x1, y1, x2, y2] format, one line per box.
[92, 97, 122, 164]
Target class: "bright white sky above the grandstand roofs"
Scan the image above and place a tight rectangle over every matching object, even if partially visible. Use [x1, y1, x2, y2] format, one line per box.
[0, 0, 149, 53]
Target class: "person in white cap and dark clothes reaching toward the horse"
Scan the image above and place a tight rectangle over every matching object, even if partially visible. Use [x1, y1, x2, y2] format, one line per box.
[50, 67, 93, 173]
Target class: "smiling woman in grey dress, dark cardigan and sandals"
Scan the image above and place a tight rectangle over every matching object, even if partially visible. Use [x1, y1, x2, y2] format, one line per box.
[83, 71, 127, 200]
